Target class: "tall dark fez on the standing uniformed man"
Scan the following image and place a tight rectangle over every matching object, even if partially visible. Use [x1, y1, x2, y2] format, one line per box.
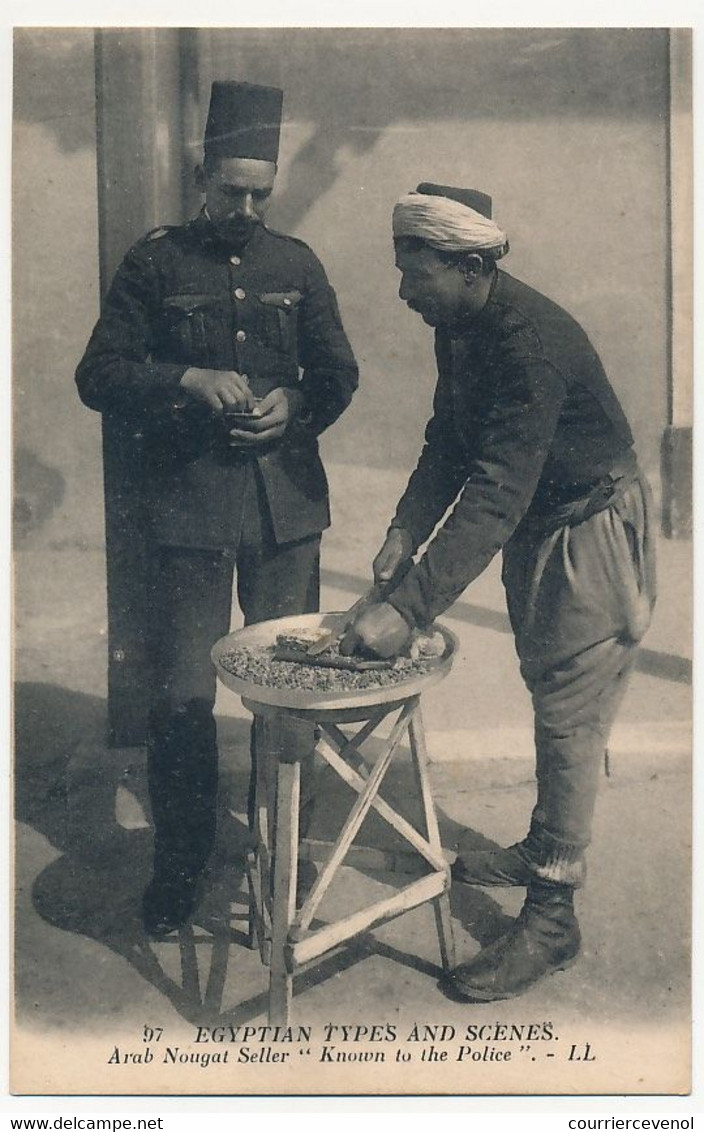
[205, 82, 283, 162]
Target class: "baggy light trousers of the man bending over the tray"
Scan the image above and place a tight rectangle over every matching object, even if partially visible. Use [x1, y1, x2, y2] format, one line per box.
[503, 468, 655, 883]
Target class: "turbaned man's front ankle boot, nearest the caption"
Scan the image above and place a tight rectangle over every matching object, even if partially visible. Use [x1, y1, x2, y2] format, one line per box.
[443, 878, 582, 1002]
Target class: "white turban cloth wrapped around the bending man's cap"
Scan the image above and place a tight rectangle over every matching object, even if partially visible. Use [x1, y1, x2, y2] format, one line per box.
[393, 192, 508, 259]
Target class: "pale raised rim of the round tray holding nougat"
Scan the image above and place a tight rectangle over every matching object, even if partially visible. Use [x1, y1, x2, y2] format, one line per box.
[211, 614, 457, 712]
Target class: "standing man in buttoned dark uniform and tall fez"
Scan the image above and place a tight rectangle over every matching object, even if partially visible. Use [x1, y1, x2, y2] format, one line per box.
[76, 82, 358, 935]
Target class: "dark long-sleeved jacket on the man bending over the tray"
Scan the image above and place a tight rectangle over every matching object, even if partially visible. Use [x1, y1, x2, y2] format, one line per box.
[388, 272, 635, 625]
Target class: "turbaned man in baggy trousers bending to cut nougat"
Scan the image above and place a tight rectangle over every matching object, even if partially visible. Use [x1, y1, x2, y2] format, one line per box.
[343, 185, 655, 1002]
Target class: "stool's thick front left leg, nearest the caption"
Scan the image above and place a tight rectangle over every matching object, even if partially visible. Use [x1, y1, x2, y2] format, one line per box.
[269, 762, 301, 1026]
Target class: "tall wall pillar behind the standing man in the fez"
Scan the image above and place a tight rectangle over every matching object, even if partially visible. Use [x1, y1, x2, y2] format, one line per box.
[95, 28, 200, 747]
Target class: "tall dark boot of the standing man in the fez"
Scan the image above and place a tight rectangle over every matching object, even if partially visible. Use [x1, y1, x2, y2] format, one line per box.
[143, 700, 217, 937]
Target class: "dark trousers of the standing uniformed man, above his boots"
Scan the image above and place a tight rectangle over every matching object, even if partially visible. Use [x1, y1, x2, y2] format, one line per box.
[147, 464, 320, 875]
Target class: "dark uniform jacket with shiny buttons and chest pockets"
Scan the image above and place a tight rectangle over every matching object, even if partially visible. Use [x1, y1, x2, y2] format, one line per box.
[76, 214, 358, 548]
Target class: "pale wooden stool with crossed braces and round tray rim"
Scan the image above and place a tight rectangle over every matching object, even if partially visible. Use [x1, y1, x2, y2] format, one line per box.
[213, 614, 456, 1024]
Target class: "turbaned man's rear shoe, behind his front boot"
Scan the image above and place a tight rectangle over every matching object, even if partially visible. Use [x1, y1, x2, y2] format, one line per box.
[450, 825, 586, 889]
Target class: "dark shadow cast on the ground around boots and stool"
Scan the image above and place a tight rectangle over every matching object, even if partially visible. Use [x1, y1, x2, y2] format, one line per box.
[15, 683, 508, 1024]
